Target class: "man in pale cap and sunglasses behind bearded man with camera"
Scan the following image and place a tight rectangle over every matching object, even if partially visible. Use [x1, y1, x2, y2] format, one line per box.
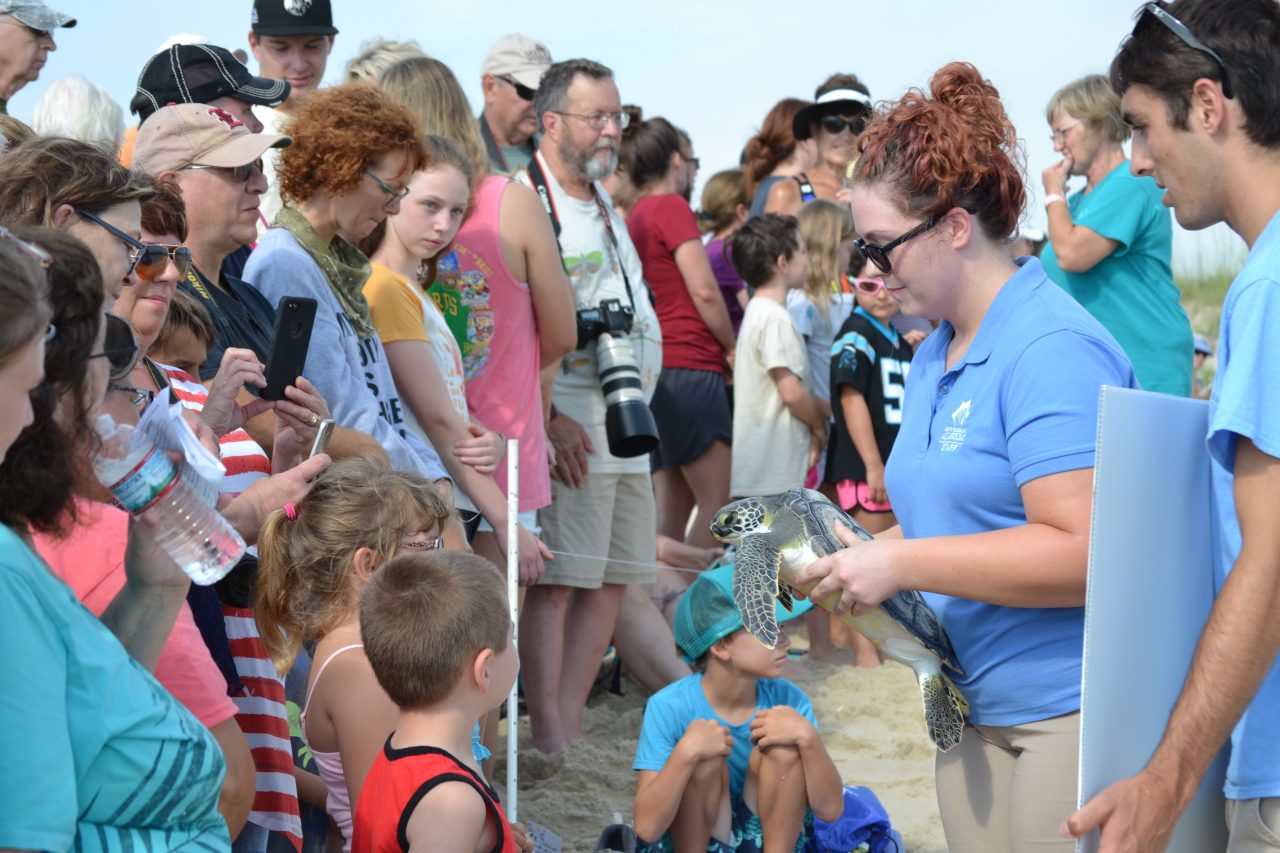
[476, 35, 552, 174]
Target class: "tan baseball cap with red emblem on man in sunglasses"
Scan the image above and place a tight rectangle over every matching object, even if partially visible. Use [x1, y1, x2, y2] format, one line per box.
[133, 104, 293, 174]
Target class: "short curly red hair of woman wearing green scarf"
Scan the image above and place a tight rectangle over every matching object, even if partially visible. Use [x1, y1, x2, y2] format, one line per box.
[276, 83, 428, 204]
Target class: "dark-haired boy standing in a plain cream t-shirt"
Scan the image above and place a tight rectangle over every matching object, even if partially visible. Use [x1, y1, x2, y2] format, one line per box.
[730, 214, 827, 497]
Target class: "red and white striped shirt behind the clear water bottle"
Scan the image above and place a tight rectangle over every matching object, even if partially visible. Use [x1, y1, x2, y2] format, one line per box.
[159, 365, 302, 850]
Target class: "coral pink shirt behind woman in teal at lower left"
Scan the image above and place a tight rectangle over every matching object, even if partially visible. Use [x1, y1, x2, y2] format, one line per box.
[33, 498, 236, 729]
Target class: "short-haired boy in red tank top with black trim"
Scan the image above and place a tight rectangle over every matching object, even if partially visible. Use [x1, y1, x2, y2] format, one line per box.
[352, 551, 532, 853]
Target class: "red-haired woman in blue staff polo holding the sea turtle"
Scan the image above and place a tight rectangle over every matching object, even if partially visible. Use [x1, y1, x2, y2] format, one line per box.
[797, 63, 1137, 853]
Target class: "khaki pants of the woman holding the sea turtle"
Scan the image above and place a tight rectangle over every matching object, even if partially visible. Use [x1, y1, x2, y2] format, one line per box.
[934, 712, 1080, 853]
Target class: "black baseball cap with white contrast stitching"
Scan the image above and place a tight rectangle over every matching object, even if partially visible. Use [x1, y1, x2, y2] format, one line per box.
[129, 45, 292, 122]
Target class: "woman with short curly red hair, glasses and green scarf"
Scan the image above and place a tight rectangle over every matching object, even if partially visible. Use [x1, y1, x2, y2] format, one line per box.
[244, 83, 449, 479]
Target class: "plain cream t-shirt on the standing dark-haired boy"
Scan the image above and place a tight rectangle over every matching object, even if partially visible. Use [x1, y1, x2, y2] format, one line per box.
[730, 296, 812, 497]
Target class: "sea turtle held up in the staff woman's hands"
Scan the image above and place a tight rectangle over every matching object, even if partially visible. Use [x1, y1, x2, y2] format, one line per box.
[710, 489, 969, 752]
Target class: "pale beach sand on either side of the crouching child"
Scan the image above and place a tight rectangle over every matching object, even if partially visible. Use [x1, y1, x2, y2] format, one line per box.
[494, 650, 946, 853]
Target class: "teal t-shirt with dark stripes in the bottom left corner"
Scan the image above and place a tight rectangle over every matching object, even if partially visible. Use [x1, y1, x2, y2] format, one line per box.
[0, 525, 230, 850]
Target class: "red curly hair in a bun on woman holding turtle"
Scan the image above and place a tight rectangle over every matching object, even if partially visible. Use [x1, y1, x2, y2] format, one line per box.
[856, 63, 1027, 240]
